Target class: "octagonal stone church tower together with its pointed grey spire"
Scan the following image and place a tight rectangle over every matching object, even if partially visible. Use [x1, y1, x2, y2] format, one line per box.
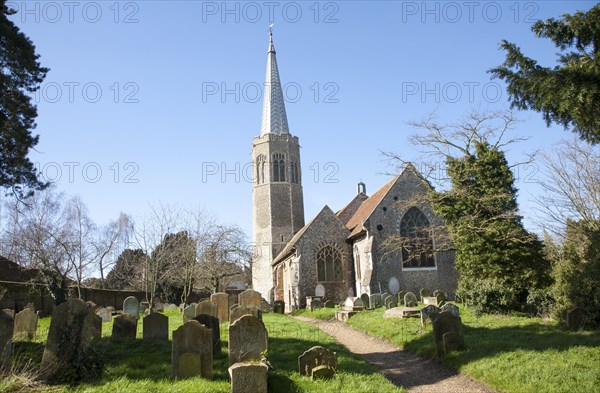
[252, 32, 304, 302]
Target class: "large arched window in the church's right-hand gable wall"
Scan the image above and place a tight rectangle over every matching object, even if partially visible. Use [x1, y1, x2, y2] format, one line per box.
[400, 206, 435, 268]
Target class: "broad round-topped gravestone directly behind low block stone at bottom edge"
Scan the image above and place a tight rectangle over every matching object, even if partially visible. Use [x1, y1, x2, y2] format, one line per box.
[229, 315, 269, 365]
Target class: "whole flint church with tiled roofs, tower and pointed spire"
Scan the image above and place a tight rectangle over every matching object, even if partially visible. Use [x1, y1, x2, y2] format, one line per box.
[252, 32, 458, 312]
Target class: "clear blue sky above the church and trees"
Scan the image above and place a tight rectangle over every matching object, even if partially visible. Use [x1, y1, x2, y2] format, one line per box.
[8, 1, 595, 236]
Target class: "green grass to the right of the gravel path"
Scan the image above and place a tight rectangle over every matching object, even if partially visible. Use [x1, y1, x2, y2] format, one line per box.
[348, 307, 600, 393]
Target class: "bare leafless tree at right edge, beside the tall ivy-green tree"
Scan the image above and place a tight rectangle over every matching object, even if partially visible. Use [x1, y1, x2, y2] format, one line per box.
[536, 138, 600, 236]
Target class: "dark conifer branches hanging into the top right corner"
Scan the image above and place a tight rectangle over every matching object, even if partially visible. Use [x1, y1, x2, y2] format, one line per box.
[490, 5, 600, 144]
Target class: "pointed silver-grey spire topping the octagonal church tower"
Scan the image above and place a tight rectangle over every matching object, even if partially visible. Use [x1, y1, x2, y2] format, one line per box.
[260, 28, 290, 136]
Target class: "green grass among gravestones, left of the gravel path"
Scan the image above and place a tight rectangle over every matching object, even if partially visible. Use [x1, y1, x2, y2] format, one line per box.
[0, 310, 404, 393]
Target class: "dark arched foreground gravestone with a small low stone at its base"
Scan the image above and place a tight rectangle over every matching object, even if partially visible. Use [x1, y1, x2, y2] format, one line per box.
[171, 321, 213, 379]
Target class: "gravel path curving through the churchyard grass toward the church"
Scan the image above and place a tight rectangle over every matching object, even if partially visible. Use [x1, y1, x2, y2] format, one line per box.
[296, 316, 494, 393]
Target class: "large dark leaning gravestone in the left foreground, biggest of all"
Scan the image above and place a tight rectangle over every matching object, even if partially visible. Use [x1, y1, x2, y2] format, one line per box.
[40, 299, 102, 382]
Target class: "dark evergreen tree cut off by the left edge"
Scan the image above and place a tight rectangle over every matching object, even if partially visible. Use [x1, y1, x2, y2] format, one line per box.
[0, 0, 48, 198]
